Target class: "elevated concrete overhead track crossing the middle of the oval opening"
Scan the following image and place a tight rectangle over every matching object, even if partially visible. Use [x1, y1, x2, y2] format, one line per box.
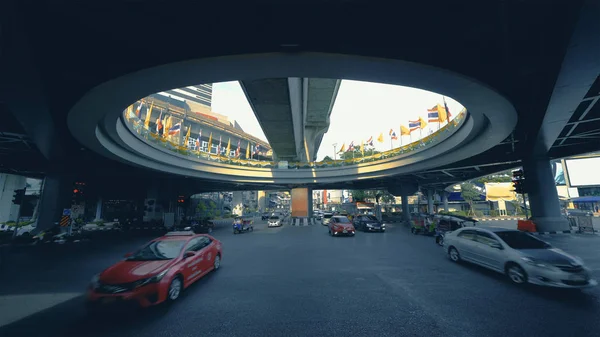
[240, 78, 341, 162]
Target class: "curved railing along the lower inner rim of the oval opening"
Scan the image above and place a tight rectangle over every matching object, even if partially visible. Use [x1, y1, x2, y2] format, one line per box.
[123, 109, 468, 169]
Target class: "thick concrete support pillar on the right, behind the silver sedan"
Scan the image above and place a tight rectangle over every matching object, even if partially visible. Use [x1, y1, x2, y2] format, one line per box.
[523, 157, 570, 232]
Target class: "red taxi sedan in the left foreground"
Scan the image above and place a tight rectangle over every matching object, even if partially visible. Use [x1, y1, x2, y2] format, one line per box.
[87, 232, 222, 309]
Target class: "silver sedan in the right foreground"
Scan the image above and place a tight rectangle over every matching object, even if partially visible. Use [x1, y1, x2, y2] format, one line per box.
[444, 227, 597, 288]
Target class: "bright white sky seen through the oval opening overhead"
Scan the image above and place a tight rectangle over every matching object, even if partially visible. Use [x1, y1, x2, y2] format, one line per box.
[212, 80, 463, 160]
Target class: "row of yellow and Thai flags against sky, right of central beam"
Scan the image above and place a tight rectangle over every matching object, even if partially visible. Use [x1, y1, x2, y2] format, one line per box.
[337, 98, 452, 156]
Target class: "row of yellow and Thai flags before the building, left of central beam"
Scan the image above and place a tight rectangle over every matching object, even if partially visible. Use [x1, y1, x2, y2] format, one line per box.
[126, 100, 264, 159]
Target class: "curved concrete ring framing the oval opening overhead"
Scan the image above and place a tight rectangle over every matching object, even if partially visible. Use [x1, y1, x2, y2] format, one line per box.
[68, 53, 517, 184]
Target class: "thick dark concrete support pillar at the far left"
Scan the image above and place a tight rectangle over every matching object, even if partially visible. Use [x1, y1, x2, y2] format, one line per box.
[36, 175, 73, 232]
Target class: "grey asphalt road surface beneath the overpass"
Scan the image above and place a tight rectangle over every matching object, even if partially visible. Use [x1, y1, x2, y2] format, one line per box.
[0, 219, 600, 337]
